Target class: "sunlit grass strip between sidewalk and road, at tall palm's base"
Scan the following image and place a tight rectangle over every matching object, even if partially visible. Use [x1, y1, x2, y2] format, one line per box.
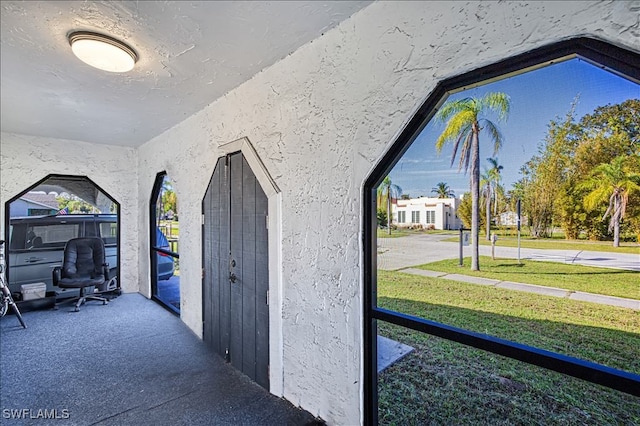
[418, 256, 640, 299]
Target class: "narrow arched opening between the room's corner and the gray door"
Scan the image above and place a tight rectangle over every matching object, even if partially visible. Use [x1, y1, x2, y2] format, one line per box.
[149, 172, 180, 315]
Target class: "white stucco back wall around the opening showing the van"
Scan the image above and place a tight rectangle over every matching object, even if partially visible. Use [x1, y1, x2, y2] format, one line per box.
[0, 132, 139, 292]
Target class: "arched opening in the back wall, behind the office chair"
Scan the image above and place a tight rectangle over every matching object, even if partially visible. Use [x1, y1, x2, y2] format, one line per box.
[4, 174, 120, 300]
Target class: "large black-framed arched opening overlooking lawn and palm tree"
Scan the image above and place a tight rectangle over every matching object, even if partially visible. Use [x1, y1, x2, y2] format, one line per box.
[363, 38, 640, 424]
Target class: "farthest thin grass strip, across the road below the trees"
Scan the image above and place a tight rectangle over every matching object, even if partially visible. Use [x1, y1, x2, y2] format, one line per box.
[444, 235, 640, 254]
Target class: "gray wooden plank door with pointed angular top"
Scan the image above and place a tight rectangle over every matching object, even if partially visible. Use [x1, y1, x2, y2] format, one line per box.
[202, 152, 269, 389]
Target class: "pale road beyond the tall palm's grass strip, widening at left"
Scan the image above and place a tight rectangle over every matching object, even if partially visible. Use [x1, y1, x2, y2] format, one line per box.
[378, 234, 640, 272]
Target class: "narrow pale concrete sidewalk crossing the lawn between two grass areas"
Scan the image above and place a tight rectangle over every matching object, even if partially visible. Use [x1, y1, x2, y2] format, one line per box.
[398, 268, 640, 311]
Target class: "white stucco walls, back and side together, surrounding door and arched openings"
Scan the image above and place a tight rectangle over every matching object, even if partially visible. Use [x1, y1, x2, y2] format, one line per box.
[0, 1, 640, 425]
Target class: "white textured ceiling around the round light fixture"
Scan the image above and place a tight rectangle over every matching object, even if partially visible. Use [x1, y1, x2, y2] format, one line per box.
[0, 1, 370, 147]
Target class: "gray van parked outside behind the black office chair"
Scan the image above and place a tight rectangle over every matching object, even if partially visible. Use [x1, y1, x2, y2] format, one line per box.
[8, 214, 119, 298]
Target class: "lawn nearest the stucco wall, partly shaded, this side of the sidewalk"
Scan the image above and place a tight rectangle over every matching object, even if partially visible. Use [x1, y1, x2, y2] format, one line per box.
[378, 271, 640, 425]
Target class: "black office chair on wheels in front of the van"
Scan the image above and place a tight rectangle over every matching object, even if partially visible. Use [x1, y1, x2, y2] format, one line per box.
[53, 237, 109, 312]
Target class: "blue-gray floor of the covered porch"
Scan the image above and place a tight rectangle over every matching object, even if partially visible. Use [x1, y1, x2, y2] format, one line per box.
[0, 294, 322, 426]
